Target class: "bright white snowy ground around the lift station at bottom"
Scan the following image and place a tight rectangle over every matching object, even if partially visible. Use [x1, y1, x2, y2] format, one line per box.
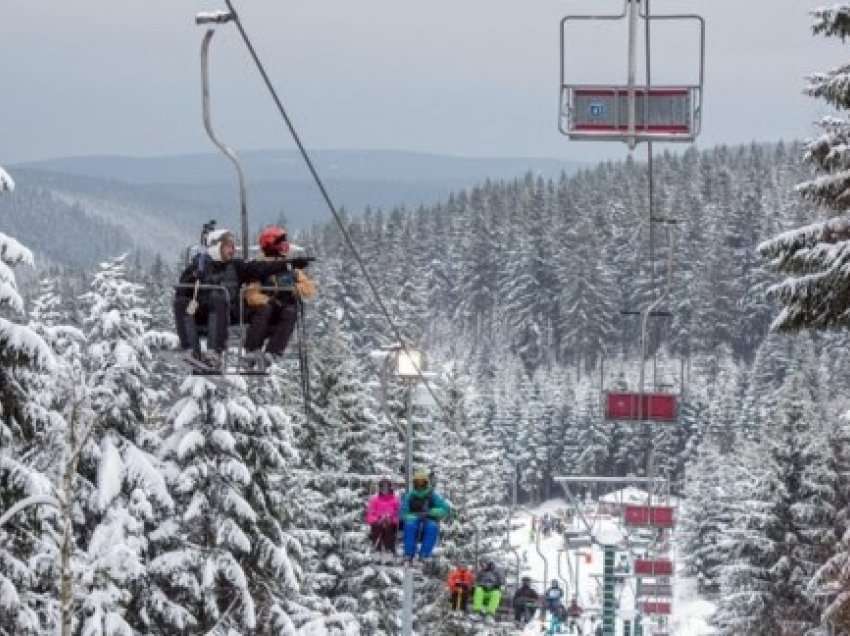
[511, 499, 714, 636]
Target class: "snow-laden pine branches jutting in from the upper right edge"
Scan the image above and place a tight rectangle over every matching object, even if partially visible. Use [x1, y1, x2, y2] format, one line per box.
[759, 2, 850, 331]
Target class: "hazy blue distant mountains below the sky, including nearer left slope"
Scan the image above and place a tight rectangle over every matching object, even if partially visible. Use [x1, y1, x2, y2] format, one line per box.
[0, 150, 583, 266]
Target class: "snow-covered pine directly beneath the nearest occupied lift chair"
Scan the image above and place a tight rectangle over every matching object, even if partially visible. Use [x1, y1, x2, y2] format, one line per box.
[156, 370, 323, 634]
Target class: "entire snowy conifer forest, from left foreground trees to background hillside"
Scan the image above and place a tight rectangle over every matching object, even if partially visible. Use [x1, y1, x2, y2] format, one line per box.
[0, 144, 850, 634]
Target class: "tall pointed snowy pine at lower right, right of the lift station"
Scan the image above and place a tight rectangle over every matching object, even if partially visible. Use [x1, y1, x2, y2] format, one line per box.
[714, 370, 838, 636]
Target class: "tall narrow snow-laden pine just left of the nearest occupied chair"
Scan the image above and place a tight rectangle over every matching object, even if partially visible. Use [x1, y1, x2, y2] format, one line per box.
[79, 257, 173, 635]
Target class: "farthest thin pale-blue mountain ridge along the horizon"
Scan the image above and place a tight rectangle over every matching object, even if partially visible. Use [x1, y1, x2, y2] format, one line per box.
[11, 150, 585, 184]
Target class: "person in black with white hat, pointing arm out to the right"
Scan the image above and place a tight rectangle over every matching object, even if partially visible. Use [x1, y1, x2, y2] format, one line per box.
[173, 229, 296, 373]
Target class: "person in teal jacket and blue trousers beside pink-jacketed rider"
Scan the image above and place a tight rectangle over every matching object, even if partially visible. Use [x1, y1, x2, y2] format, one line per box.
[401, 470, 451, 564]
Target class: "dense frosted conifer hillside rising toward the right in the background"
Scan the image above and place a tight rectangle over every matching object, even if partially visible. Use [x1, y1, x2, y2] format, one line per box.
[308, 144, 810, 372]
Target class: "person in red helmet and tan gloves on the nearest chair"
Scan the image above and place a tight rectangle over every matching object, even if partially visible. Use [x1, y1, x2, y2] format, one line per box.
[245, 225, 315, 356]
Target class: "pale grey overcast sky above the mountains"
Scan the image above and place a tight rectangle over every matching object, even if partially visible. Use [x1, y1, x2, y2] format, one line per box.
[0, 0, 850, 163]
